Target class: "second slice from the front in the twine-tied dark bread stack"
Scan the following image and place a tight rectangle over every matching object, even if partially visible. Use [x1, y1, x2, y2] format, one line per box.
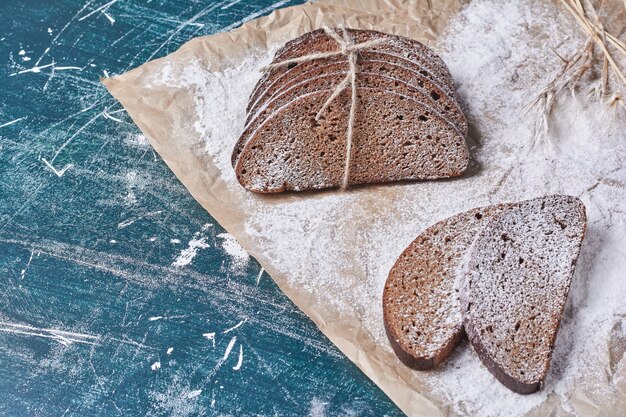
[231, 72, 467, 166]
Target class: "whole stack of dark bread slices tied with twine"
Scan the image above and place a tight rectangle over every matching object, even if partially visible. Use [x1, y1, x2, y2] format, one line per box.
[232, 28, 468, 193]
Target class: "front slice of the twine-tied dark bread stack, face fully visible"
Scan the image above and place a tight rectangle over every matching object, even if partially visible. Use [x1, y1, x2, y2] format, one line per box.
[235, 88, 468, 193]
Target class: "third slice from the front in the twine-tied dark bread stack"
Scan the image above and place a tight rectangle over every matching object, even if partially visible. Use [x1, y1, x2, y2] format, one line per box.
[246, 59, 468, 135]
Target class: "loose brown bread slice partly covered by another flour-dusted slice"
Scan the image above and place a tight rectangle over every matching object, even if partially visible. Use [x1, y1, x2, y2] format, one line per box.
[383, 205, 505, 370]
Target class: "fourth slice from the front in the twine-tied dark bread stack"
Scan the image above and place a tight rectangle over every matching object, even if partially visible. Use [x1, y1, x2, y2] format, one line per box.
[246, 51, 459, 115]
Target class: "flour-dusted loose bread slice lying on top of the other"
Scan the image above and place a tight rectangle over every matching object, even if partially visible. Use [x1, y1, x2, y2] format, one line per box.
[461, 195, 586, 394]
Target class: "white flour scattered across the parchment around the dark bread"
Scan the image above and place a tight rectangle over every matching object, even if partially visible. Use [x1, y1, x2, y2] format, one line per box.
[144, 0, 626, 416]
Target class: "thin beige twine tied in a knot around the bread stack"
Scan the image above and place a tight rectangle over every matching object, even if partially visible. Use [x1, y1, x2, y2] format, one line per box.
[262, 26, 387, 190]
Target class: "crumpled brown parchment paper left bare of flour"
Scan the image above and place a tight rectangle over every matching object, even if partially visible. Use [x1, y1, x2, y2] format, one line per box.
[103, 0, 626, 417]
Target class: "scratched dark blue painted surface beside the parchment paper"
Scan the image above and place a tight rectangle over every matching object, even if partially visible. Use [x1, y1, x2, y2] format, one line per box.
[0, 0, 400, 416]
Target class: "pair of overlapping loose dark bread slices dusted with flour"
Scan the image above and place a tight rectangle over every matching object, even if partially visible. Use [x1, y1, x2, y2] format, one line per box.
[383, 195, 586, 394]
